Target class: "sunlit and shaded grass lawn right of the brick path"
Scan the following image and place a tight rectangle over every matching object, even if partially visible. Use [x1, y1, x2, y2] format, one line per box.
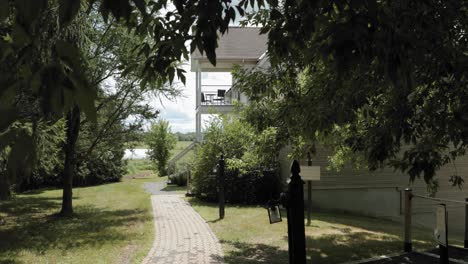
[189, 198, 461, 264]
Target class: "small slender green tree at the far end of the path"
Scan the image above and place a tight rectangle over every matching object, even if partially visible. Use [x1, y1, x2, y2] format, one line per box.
[146, 119, 177, 177]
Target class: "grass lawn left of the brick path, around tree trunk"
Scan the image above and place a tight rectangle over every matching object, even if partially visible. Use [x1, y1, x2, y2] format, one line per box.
[0, 176, 165, 263]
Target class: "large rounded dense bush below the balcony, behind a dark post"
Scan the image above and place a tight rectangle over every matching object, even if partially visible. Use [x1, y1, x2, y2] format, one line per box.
[192, 116, 281, 204]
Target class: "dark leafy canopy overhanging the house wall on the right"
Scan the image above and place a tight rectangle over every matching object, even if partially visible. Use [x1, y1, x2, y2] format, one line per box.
[235, 0, 468, 188]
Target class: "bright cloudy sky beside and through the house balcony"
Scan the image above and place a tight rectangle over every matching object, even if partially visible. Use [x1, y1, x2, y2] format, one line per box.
[153, 62, 232, 133]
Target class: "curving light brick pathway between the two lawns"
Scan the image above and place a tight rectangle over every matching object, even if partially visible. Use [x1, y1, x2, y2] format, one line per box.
[143, 195, 224, 264]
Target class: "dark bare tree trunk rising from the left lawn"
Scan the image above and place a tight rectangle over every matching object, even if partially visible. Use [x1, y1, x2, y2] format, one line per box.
[60, 106, 80, 216]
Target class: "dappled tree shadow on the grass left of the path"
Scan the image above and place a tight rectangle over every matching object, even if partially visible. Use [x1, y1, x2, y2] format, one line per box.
[0, 196, 148, 263]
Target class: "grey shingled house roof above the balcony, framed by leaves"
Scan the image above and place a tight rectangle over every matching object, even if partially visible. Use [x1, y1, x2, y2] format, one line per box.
[192, 27, 267, 60]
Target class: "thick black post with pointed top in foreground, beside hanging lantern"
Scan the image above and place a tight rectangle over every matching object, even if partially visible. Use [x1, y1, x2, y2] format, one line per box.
[287, 160, 306, 264]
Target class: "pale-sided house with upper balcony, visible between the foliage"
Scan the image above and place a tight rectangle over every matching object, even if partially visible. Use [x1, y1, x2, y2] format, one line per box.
[191, 27, 468, 236]
